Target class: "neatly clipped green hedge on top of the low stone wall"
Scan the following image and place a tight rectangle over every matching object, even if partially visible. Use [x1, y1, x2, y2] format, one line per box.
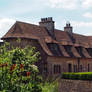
[62, 72, 92, 80]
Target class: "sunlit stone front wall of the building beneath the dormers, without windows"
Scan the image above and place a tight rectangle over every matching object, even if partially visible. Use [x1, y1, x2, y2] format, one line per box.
[47, 56, 92, 75]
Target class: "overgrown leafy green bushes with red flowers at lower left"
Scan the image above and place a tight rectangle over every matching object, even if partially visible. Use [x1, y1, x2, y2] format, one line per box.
[0, 43, 58, 92]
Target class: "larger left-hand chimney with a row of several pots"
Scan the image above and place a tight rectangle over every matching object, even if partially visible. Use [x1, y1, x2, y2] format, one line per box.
[39, 17, 55, 39]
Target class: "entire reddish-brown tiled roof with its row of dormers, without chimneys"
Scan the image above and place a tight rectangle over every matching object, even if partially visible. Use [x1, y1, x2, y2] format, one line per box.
[2, 21, 92, 58]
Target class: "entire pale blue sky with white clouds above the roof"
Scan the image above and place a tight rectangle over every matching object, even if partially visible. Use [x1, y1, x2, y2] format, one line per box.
[0, 0, 92, 38]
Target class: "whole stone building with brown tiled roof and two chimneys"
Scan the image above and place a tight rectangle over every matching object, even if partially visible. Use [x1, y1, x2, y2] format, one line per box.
[2, 17, 92, 76]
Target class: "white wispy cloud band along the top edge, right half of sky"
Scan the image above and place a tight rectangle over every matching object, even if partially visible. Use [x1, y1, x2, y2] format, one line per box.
[44, 0, 92, 10]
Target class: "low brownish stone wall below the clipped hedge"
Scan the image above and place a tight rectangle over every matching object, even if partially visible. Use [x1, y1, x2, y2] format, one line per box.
[59, 79, 92, 92]
